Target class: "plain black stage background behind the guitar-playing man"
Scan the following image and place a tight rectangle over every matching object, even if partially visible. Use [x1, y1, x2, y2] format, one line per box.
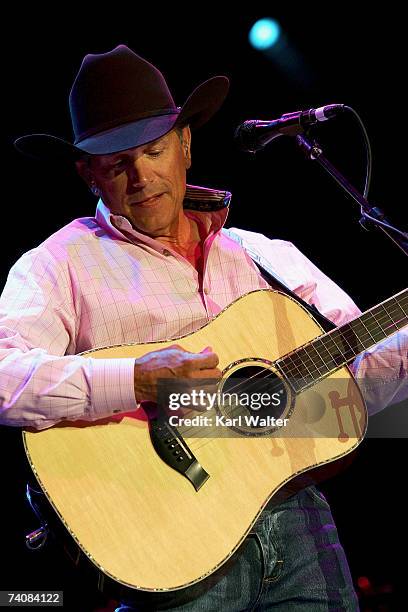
[0, 9, 408, 610]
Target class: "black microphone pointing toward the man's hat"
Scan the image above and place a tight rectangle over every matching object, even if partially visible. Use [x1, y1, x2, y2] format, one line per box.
[235, 104, 347, 153]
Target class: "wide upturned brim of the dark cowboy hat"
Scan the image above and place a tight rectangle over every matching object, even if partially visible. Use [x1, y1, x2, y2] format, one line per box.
[14, 76, 229, 161]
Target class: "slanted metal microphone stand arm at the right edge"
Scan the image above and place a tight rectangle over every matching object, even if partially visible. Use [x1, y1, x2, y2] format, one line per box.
[296, 134, 408, 255]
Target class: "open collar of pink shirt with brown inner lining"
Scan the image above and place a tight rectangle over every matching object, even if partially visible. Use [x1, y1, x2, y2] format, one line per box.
[95, 185, 232, 246]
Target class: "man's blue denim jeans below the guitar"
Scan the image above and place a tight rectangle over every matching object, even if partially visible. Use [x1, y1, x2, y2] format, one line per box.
[118, 486, 359, 612]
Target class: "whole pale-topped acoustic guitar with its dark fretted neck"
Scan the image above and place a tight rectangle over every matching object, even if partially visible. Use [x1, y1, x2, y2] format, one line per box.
[23, 289, 408, 591]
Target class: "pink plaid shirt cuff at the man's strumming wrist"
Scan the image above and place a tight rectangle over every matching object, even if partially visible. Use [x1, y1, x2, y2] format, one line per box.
[89, 358, 138, 419]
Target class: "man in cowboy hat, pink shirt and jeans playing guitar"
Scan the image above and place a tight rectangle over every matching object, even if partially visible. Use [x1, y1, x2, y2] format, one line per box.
[0, 45, 407, 612]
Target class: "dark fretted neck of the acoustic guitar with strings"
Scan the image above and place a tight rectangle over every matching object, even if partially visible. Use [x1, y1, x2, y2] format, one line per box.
[275, 289, 408, 392]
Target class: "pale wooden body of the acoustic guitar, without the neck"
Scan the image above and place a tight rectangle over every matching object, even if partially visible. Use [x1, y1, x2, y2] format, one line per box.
[23, 290, 367, 591]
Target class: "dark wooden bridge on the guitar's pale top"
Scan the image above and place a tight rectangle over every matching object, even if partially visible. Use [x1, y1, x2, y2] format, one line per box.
[149, 417, 210, 491]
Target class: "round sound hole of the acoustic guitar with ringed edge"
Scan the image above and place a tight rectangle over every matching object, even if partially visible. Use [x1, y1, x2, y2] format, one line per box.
[218, 365, 290, 434]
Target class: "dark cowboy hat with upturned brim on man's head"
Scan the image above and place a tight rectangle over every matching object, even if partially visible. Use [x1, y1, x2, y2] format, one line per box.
[14, 45, 229, 160]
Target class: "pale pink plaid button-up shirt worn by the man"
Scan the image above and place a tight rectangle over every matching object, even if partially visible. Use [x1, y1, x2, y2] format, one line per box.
[0, 186, 408, 429]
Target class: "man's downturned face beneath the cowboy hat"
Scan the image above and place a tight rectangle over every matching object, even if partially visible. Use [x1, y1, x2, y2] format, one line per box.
[78, 127, 191, 237]
